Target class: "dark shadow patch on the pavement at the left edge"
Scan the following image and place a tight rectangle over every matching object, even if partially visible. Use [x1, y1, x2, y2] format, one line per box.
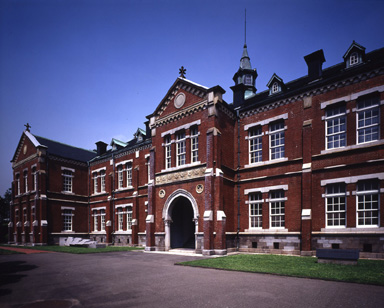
[0, 261, 37, 296]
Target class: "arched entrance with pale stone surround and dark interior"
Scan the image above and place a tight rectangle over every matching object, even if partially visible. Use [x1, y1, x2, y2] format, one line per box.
[163, 189, 199, 250]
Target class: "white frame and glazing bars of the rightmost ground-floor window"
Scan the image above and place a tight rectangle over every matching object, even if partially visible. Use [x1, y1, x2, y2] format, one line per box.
[356, 180, 380, 228]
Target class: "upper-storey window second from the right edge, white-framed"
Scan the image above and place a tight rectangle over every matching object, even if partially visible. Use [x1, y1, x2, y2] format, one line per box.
[325, 106, 346, 149]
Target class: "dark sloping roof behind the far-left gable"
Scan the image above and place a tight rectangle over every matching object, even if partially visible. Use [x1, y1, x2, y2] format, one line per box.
[33, 135, 97, 162]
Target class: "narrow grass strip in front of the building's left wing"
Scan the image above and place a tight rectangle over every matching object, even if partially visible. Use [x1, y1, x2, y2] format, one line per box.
[0, 245, 143, 254]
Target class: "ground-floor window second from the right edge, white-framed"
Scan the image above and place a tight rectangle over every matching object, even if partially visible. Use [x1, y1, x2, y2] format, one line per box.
[325, 183, 346, 227]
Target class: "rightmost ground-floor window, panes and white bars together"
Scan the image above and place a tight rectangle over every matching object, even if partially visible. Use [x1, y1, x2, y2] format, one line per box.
[356, 181, 379, 227]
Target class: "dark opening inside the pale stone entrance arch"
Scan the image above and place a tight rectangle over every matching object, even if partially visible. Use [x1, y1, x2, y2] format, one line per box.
[171, 197, 195, 249]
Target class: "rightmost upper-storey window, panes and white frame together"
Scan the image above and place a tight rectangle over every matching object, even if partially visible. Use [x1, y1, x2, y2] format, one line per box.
[357, 96, 380, 143]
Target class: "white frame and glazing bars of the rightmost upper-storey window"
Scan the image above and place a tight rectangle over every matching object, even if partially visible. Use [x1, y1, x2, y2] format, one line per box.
[356, 96, 380, 144]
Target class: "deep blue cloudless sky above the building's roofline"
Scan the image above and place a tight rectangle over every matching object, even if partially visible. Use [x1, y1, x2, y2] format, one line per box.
[0, 0, 384, 195]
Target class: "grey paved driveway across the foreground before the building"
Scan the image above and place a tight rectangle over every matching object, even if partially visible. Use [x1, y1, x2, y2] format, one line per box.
[0, 251, 384, 308]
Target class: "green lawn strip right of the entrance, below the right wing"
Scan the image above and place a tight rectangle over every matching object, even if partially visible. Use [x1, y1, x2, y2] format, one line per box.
[178, 255, 384, 286]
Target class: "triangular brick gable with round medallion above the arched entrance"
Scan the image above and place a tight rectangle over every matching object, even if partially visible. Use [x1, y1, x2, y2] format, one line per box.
[149, 77, 208, 119]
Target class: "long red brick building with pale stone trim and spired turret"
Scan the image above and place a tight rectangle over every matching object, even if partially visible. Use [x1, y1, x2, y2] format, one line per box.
[10, 42, 384, 257]
